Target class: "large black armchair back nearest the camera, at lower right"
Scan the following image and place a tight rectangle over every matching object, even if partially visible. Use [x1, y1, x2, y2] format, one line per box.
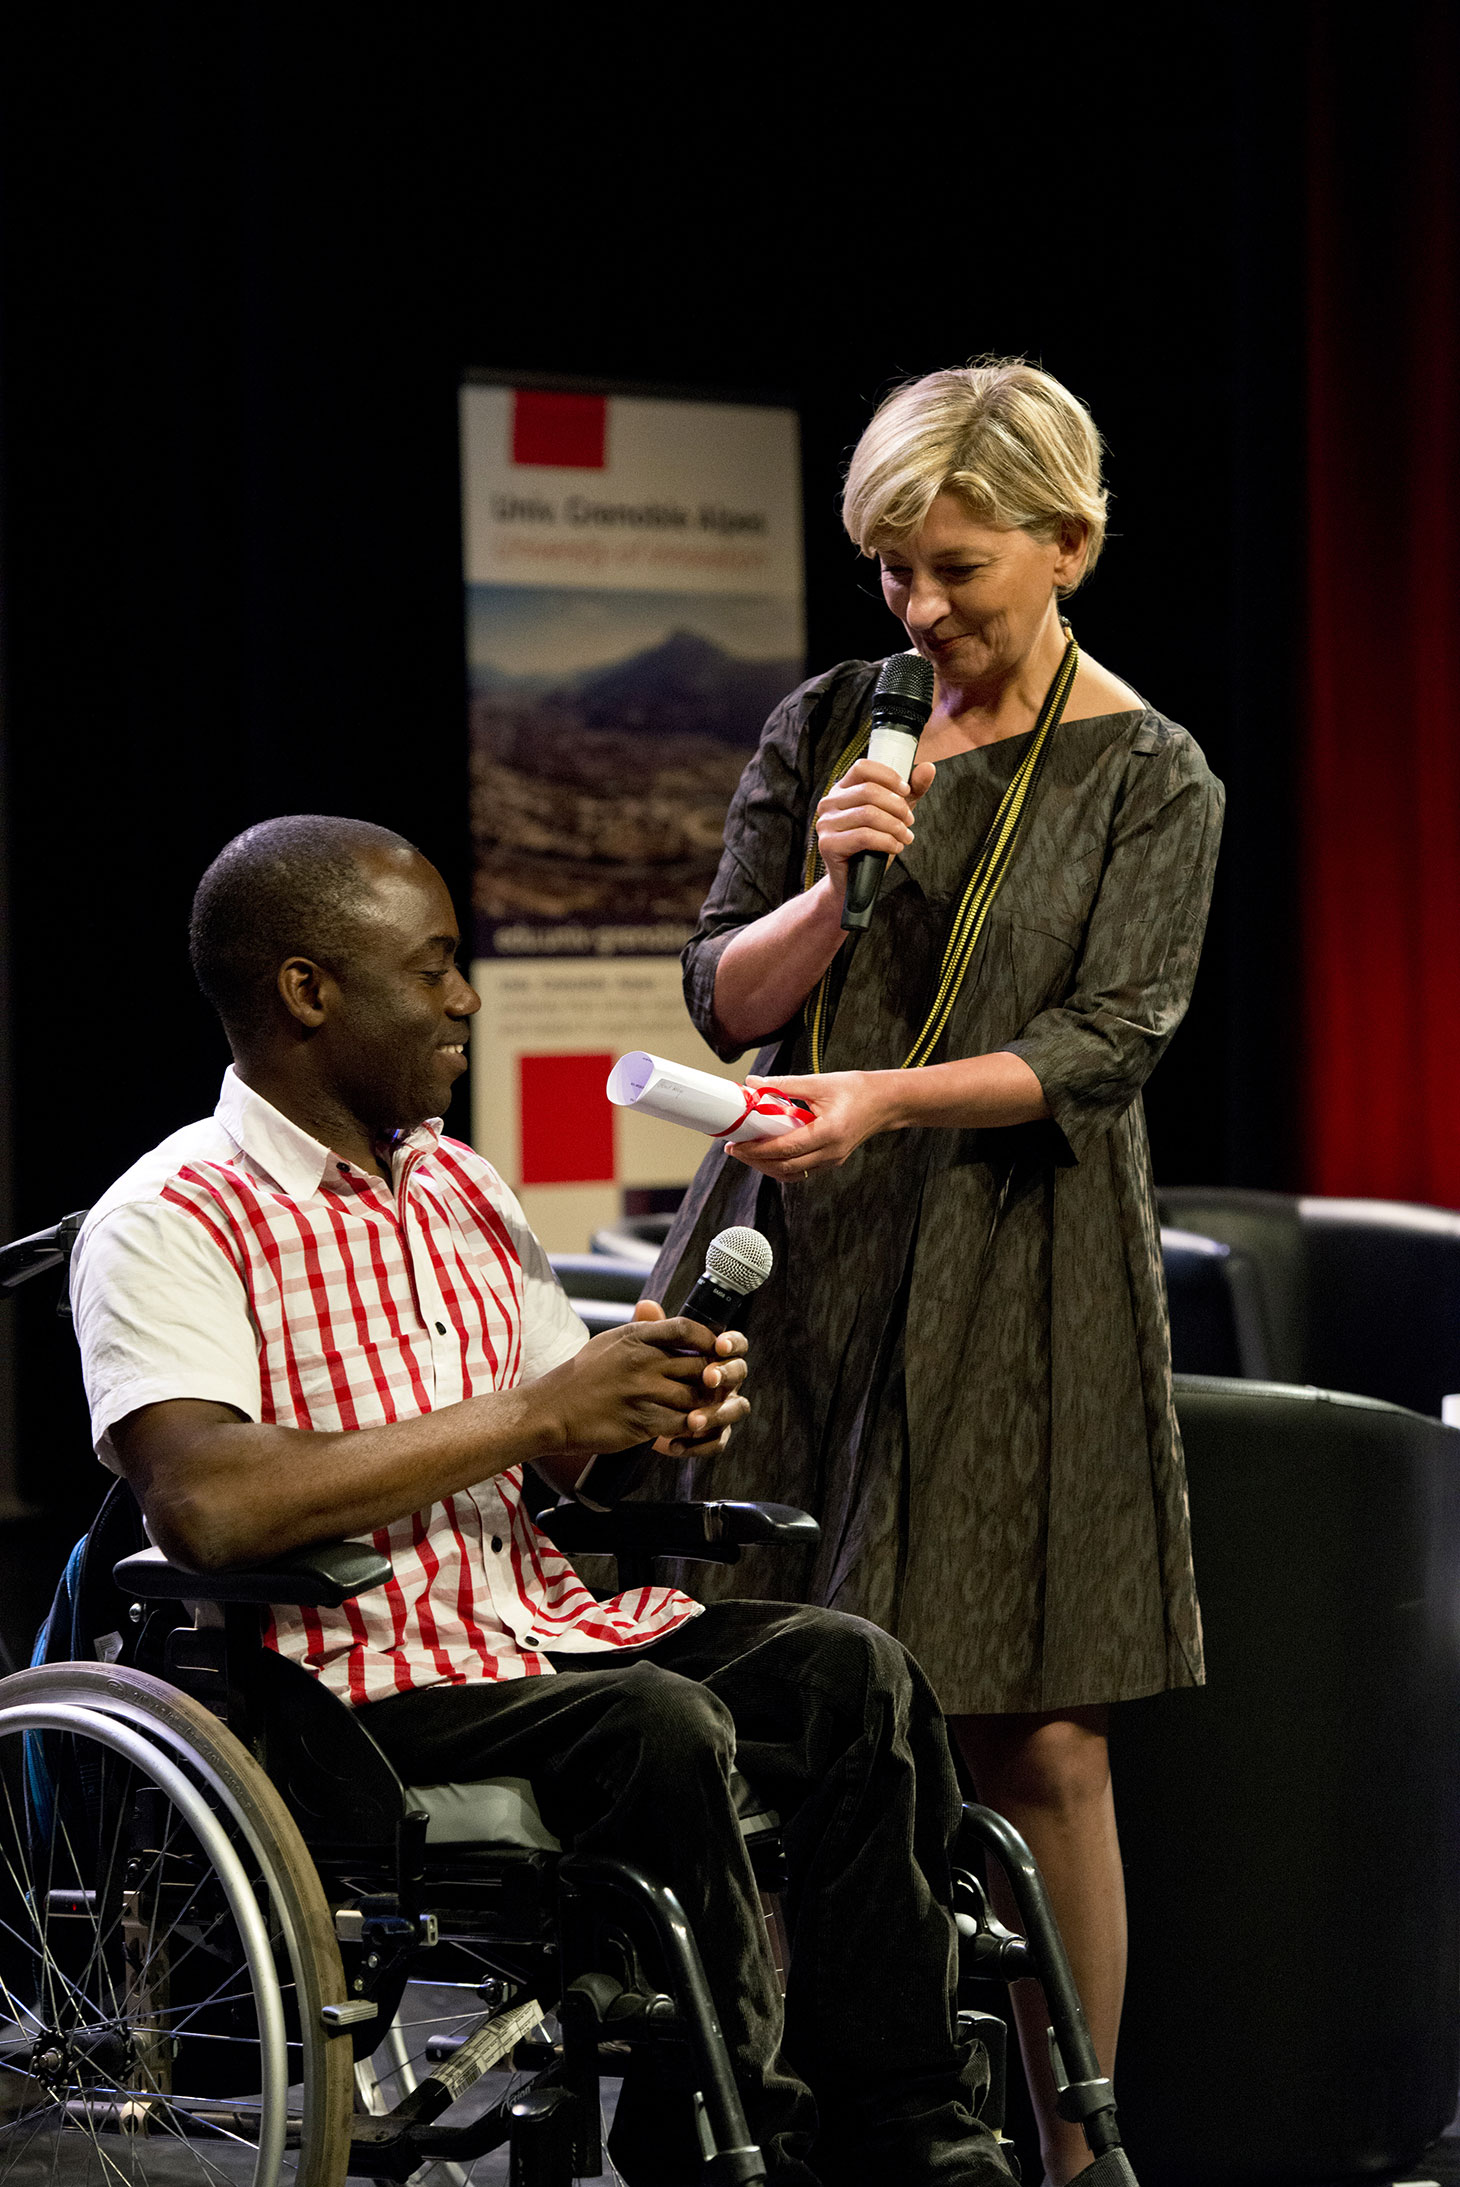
[1112, 1378, 1460, 2187]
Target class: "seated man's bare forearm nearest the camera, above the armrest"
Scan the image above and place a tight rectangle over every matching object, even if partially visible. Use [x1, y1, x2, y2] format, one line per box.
[118, 1384, 563, 1570]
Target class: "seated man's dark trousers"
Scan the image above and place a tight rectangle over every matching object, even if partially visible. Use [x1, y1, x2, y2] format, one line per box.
[361, 1603, 1010, 2187]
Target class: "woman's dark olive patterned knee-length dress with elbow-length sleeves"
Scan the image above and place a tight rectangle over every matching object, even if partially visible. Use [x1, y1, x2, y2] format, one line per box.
[649, 660, 1222, 1715]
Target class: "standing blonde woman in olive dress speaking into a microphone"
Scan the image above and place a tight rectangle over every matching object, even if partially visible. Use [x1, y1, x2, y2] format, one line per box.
[649, 363, 1222, 2187]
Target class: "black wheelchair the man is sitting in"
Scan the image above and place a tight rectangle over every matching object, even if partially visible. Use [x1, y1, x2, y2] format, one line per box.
[0, 1216, 1134, 2187]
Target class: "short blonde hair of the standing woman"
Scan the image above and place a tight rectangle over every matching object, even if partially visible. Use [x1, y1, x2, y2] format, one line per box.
[841, 356, 1106, 590]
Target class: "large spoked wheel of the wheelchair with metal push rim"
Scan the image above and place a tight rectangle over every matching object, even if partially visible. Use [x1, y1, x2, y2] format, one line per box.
[0, 1662, 354, 2187]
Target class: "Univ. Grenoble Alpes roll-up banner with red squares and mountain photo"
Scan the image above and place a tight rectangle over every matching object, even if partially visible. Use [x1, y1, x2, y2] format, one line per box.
[461, 374, 804, 1253]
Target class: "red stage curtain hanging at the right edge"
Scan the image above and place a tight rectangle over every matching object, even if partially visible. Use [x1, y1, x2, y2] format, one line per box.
[1302, 4, 1460, 1207]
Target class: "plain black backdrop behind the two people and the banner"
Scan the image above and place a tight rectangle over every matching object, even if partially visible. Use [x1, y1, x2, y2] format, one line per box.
[0, 4, 1305, 1498]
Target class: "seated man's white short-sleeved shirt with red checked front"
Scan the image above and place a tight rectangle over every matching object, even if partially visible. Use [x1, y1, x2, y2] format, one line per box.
[72, 1069, 699, 1704]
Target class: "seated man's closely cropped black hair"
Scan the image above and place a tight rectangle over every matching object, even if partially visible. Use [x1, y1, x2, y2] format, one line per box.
[188, 814, 415, 1034]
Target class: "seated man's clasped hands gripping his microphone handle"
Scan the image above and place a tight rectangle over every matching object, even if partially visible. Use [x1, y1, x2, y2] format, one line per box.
[531, 1299, 750, 1459]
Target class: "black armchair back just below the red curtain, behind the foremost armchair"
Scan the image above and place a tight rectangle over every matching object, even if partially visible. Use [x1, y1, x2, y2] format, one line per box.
[1158, 1185, 1460, 1415]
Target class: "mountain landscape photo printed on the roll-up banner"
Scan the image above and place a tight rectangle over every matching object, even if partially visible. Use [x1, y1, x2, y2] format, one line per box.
[468, 584, 802, 956]
